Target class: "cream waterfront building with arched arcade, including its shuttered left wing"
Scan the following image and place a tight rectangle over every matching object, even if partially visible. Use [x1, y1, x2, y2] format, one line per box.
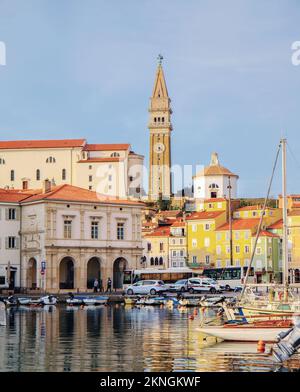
[0, 181, 144, 292]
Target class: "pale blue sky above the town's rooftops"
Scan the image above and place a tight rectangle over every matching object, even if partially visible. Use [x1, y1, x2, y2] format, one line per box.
[0, 0, 300, 197]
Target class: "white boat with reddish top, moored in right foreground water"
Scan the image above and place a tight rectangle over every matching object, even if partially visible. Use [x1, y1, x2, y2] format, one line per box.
[198, 320, 293, 342]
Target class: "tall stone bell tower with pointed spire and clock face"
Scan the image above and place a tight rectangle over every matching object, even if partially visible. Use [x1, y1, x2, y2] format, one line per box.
[148, 55, 172, 201]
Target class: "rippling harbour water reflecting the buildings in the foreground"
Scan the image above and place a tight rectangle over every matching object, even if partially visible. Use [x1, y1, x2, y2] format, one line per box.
[0, 305, 300, 372]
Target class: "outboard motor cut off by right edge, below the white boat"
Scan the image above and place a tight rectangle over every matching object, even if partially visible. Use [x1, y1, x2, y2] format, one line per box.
[272, 317, 300, 362]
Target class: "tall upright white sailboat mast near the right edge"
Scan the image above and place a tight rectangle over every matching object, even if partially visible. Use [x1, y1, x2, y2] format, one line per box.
[280, 139, 289, 288]
